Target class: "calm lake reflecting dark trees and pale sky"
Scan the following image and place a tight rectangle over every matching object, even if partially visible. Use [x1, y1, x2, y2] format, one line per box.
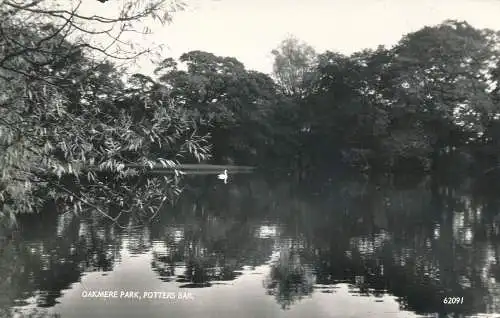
[0, 174, 500, 318]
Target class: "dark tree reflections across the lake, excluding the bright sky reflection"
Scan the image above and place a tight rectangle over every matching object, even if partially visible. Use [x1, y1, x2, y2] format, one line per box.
[0, 173, 500, 316]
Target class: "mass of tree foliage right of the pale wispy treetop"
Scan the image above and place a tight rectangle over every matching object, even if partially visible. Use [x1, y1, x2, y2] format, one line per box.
[292, 21, 499, 168]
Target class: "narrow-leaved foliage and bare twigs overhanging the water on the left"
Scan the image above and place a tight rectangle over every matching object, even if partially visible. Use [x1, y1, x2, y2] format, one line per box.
[0, 1, 209, 226]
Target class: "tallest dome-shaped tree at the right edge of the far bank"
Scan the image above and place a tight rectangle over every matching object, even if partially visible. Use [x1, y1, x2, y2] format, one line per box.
[382, 21, 499, 170]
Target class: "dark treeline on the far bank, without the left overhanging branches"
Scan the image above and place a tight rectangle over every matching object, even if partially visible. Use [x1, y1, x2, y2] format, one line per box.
[127, 21, 499, 176]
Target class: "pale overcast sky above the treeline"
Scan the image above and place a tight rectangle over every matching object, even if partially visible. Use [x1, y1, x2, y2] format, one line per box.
[81, 0, 500, 73]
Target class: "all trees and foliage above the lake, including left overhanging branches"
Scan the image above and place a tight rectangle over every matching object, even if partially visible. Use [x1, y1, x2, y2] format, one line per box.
[0, 0, 500, 224]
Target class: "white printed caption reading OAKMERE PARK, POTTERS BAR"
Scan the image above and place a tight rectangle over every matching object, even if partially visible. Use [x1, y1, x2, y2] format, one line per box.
[81, 290, 194, 300]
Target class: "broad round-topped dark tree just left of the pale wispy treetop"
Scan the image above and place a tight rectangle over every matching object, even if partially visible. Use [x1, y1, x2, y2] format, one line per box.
[158, 51, 277, 163]
